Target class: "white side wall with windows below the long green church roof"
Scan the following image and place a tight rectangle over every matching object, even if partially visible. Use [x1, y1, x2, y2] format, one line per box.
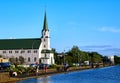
[0, 49, 39, 64]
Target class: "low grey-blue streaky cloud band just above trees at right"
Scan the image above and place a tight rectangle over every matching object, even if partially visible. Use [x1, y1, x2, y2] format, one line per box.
[80, 45, 120, 56]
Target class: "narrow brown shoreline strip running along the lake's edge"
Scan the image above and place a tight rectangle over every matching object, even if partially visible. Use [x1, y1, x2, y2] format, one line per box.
[0, 66, 112, 83]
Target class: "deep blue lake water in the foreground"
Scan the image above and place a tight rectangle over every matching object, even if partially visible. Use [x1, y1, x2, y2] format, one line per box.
[16, 66, 120, 83]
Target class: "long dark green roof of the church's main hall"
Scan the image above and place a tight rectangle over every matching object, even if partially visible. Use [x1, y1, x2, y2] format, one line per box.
[0, 38, 41, 50]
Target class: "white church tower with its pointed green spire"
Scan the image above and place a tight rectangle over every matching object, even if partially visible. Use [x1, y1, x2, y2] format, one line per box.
[41, 11, 54, 65]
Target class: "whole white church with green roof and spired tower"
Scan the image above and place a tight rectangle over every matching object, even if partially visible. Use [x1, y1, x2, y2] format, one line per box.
[0, 12, 55, 65]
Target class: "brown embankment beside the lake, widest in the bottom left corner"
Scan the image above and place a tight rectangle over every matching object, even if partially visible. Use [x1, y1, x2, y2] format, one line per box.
[0, 66, 111, 83]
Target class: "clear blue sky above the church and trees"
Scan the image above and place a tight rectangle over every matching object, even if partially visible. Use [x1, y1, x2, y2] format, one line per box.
[0, 0, 120, 56]
